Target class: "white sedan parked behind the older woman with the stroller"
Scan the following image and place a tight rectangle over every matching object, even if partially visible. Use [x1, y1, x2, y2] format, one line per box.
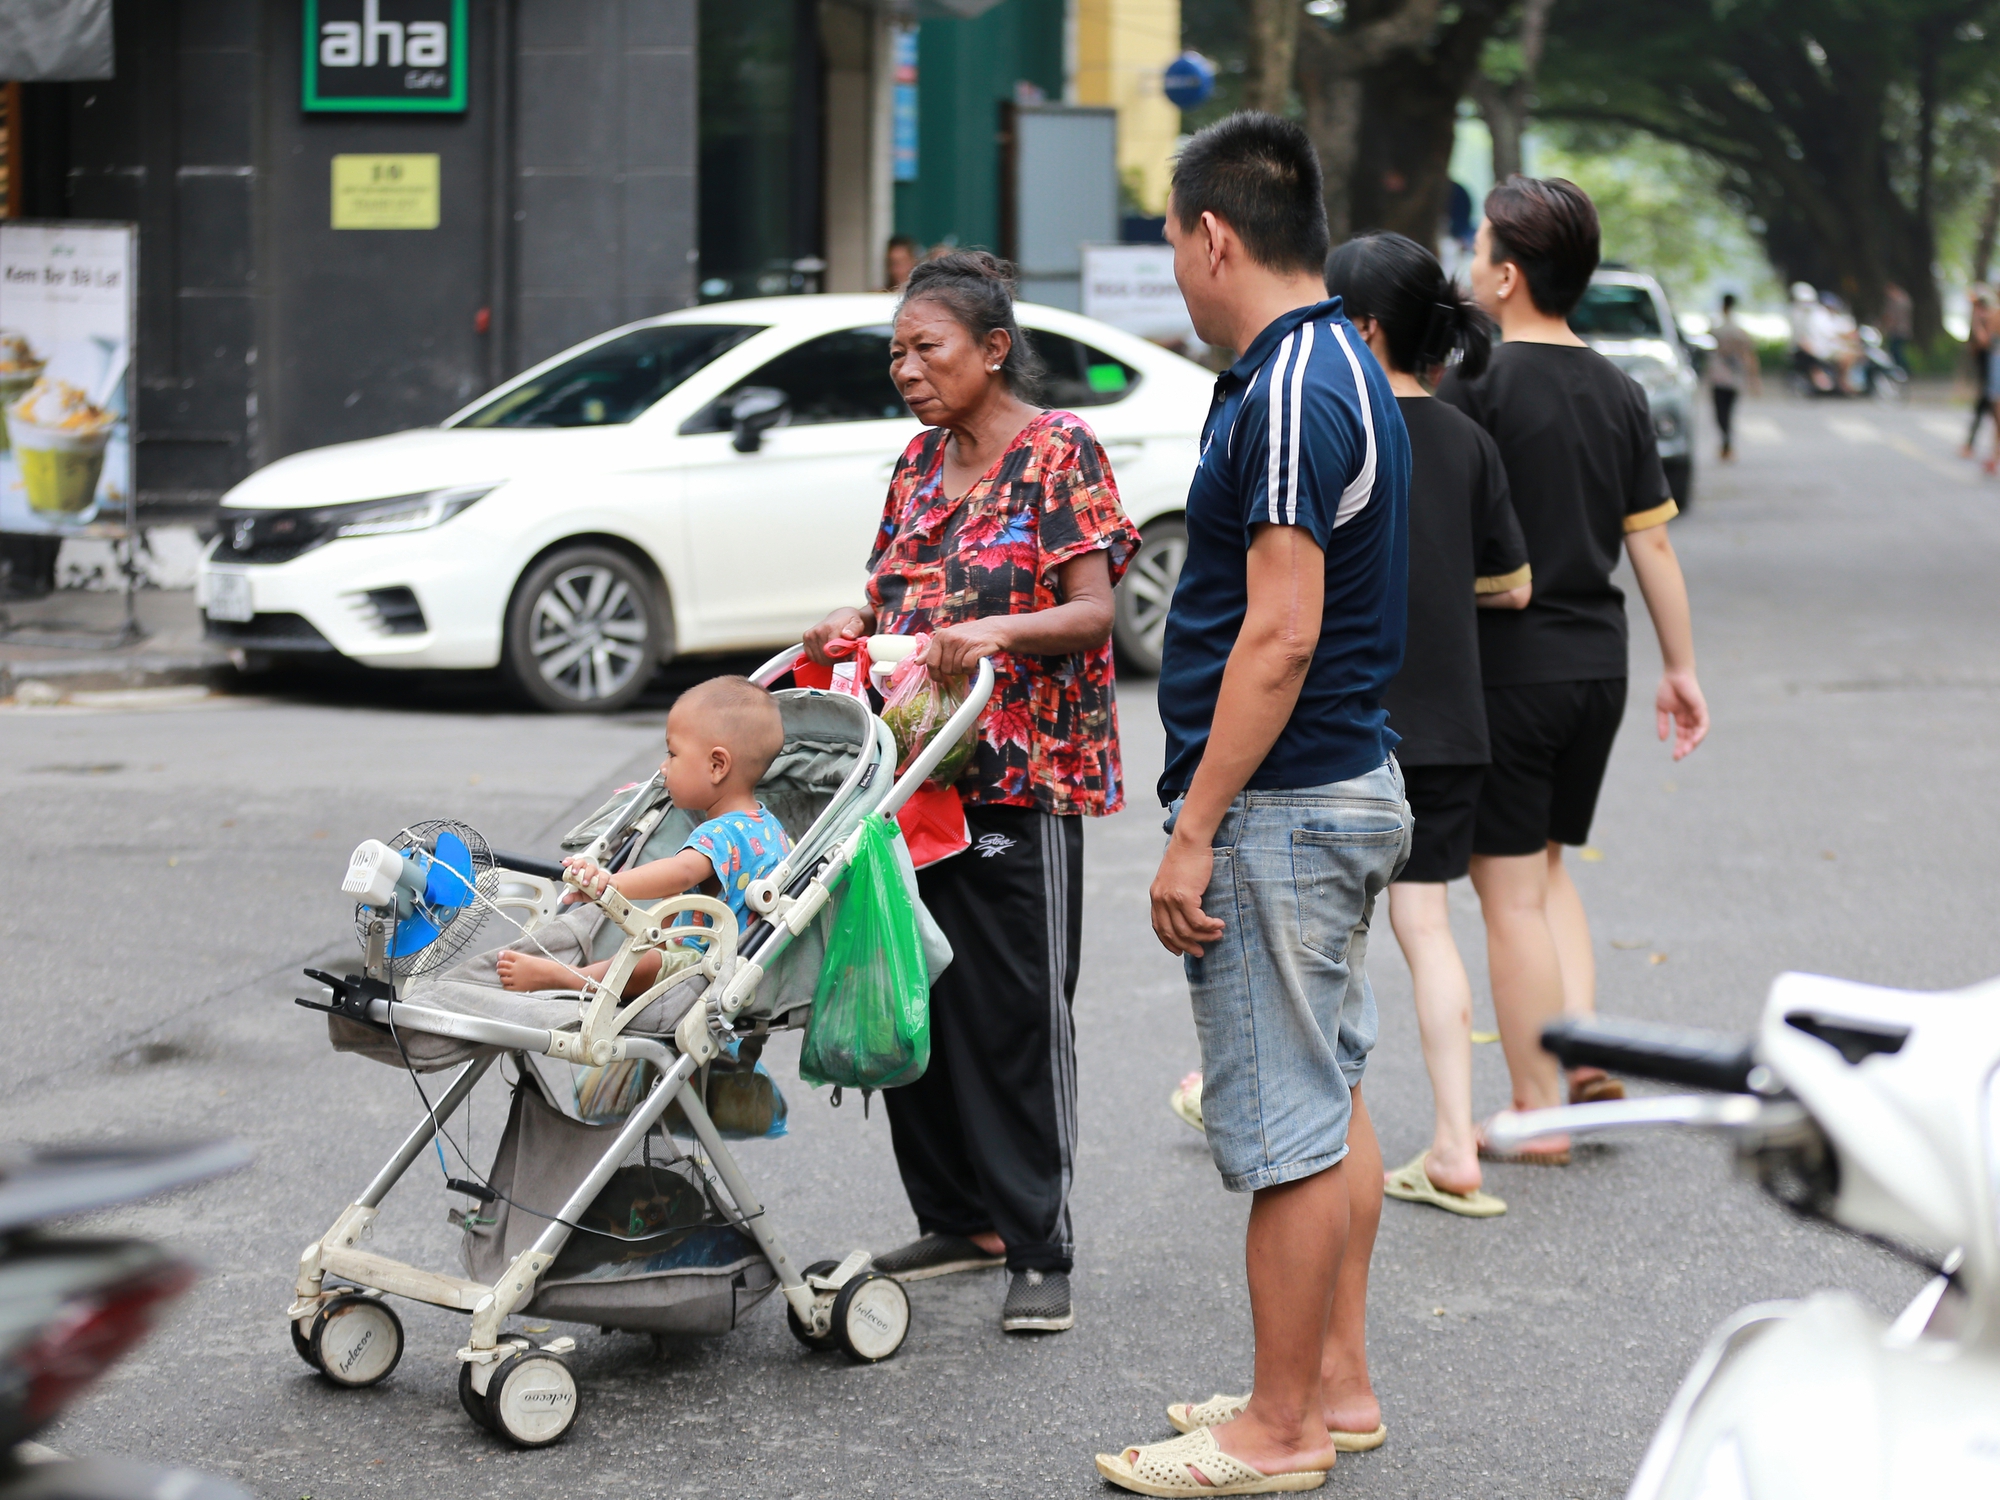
[198, 296, 1212, 710]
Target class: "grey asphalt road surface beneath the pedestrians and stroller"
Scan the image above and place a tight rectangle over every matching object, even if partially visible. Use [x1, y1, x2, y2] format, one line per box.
[0, 400, 2000, 1500]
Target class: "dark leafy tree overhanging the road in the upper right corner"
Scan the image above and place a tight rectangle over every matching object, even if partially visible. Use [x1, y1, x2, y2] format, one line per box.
[1538, 0, 2000, 342]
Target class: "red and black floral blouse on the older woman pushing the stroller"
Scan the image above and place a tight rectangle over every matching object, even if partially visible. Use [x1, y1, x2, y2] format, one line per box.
[868, 412, 1138, 814]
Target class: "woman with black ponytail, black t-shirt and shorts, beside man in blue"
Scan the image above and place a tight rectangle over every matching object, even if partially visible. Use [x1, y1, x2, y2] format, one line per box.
[1326, 234, 1530, 1218]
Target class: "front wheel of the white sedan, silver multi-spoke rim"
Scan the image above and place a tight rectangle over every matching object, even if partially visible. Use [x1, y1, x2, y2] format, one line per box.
[506, 546, 666, 714]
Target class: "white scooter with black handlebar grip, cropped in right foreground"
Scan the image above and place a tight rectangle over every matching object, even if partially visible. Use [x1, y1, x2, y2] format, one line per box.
[1490, 974, 2000, 1500]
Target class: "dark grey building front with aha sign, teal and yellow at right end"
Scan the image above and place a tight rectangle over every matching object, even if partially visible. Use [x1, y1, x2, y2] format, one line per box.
[0, 0, 1178, 518]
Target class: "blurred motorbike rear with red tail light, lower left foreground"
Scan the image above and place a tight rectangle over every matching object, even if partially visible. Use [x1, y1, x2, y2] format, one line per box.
[0, 1142, 250, 1500]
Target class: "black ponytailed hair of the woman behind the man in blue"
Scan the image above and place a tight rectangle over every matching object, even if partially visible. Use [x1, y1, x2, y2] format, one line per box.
[1326, 232, 1492, 376]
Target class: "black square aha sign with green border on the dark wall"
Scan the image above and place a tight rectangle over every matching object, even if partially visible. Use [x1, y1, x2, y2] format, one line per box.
[304, 0, 466, 112]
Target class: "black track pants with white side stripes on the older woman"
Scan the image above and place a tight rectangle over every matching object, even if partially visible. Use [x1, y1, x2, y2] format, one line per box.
[882, 808, 1084, 1270]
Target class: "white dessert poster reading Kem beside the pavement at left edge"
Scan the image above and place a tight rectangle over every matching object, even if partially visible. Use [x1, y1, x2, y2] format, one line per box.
[0, 222, 138, 536]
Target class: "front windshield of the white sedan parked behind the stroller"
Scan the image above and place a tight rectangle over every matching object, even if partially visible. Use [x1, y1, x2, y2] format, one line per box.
[454, 322, 764, 428]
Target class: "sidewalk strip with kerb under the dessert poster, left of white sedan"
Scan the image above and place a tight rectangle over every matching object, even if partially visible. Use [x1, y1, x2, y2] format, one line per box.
[0, 588, 232, 702]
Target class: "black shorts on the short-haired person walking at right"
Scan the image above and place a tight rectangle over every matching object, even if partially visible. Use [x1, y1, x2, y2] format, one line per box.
[1472, 678, 1626, 856]
